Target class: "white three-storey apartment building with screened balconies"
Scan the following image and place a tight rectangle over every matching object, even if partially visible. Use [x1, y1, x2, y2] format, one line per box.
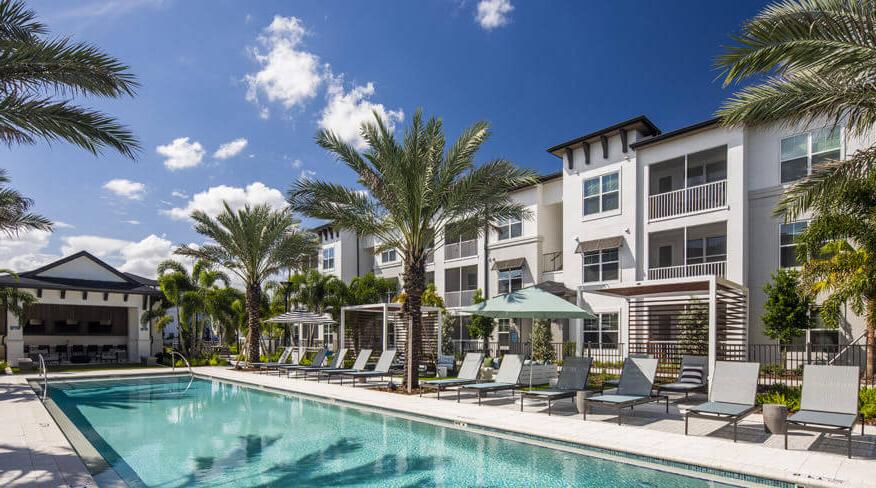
[308, 116, 874, 348]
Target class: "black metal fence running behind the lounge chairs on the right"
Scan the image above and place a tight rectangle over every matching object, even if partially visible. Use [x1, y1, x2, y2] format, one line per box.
[453, 340, 876, 387]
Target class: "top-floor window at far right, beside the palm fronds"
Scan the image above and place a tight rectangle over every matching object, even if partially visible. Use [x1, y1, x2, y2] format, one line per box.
[780, 127, 842, 183]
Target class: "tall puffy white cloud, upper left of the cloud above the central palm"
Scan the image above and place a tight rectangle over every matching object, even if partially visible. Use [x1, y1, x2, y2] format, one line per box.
[244, 15, 323, 118]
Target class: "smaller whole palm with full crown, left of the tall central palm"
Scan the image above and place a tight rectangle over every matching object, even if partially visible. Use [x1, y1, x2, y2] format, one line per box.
[174, 202, 316, 362]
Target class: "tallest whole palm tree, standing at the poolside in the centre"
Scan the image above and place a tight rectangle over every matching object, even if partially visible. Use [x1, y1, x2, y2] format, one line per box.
[289, 110, 537, 391]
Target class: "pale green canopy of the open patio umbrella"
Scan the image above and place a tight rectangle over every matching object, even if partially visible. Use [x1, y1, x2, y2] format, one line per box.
[460, 286, 594, 319]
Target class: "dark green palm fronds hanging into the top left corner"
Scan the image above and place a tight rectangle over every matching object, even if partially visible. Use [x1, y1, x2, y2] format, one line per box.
[0, 0, 140, 158]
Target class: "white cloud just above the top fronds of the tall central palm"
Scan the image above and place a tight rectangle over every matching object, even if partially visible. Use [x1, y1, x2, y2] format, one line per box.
[319, 77, 405, 149]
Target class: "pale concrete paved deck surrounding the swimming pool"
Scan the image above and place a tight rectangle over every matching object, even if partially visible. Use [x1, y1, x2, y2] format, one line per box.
[0, 367, 876, 488]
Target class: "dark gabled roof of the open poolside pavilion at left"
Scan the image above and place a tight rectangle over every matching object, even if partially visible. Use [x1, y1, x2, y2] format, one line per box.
[0, 251, 161, 295]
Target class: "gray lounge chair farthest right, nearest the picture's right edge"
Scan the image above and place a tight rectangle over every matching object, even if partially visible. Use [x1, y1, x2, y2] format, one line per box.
[785, 364, 864, 458]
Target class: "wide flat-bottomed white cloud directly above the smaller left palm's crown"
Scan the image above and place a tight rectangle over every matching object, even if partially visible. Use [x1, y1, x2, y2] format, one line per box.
[161, 181, 288, 220]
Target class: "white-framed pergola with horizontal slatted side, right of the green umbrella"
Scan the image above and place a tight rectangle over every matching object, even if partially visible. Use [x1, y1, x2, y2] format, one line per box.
[588, 276, 748, 380]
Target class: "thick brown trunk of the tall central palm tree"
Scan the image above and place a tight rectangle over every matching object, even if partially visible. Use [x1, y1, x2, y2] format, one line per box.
[402, 256, 426, 393]
